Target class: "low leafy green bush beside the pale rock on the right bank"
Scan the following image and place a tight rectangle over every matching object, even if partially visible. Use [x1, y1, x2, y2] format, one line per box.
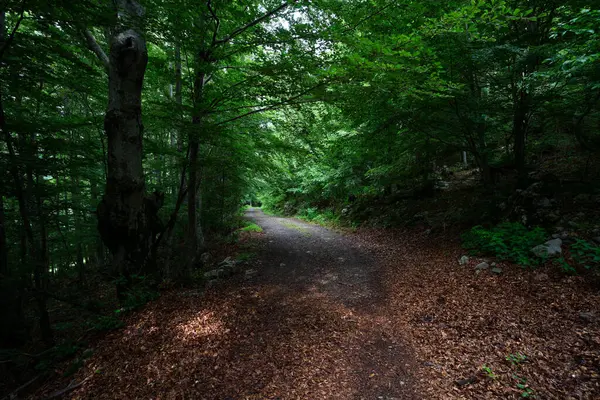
[462, 222, 547, 266]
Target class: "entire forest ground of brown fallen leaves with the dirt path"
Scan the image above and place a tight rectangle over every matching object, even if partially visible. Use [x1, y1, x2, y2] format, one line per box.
[38, 210, 600, 400]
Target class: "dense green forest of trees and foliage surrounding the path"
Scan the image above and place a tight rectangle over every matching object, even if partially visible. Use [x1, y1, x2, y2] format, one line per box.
[0, 0, 600, 396]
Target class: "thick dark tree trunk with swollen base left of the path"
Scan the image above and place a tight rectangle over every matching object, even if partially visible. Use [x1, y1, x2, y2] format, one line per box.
[97, 29, 158, 300]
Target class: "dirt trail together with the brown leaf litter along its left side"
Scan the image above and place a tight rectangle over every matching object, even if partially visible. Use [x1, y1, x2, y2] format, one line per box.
[36, 210, 416, 400]
